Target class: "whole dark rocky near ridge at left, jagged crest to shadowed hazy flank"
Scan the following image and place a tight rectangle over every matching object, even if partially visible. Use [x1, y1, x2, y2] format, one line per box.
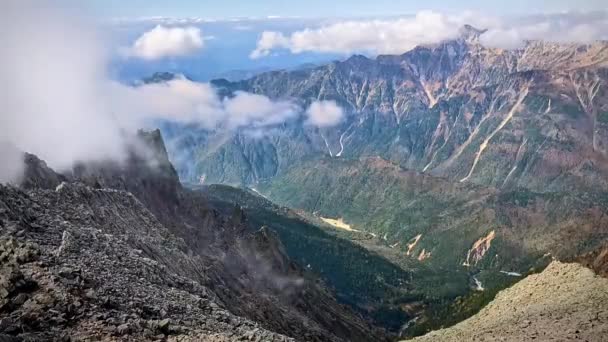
[0, 131, 384, 341]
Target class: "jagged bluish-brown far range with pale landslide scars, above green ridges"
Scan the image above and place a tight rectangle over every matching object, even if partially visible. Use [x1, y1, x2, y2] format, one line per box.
[163, 27, 608, 195]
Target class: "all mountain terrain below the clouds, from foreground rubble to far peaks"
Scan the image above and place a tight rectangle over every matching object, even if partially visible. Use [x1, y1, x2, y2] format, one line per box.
[0, 26, 608, 341]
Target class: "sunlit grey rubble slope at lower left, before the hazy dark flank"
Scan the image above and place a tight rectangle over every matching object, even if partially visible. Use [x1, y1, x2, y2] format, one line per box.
[0, 183, 289, 341]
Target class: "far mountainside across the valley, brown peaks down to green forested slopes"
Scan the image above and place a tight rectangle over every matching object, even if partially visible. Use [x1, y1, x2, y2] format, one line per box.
[152, 26, 608, 335]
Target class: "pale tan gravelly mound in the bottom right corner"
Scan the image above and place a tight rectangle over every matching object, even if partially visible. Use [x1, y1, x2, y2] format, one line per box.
[406, 261, 608, 342]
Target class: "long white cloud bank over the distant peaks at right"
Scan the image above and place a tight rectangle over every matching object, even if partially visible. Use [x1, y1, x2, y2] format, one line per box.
[250, 11, 608, 59]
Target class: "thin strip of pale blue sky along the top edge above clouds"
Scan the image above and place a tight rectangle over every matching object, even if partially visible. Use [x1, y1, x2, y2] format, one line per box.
[89, 0, 608, 18]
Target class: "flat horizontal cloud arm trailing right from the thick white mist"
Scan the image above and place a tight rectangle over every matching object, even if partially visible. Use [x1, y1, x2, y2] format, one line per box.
[113, 79, 302, 130]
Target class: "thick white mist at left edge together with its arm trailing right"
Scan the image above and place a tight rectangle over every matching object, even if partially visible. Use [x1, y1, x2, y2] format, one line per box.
[0, 0, 301, 182]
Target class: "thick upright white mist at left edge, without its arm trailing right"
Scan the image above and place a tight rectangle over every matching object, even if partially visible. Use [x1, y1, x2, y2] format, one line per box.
[0, 0, 124, 175]
